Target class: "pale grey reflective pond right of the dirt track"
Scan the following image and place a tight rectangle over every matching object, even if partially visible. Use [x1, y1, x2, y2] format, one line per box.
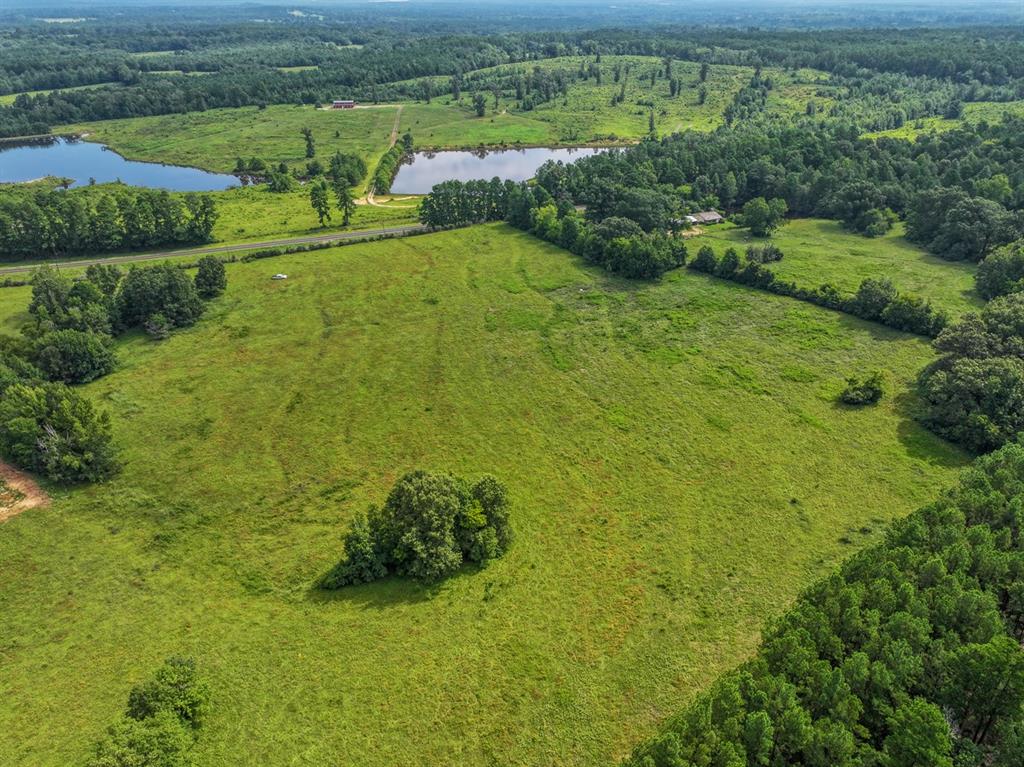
[391, 146, 605, 195]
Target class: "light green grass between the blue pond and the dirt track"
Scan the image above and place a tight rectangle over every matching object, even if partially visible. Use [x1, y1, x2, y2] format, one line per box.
[61, 105, 395, 184]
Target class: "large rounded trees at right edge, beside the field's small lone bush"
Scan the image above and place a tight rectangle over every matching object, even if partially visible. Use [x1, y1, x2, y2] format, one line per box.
[918, 293, 1024, 453]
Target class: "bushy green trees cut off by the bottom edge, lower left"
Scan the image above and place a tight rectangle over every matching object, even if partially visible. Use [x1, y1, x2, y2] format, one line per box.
[85, 657, 210, 767]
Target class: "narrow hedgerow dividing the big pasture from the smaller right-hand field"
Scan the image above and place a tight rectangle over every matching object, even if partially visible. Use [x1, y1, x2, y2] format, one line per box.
[689, 245, 948, 338]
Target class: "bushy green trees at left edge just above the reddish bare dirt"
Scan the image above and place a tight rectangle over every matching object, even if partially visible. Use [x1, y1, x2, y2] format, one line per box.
[0, 383, 118, 482]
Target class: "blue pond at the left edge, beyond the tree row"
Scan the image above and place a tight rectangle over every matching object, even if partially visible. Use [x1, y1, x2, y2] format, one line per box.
[0, 137, 241, 191]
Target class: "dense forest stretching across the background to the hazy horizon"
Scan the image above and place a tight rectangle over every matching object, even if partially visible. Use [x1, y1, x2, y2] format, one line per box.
[0, 20, 1024, 136]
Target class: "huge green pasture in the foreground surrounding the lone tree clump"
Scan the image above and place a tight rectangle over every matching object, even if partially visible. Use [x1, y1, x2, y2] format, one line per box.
[0, 225, 964, 767]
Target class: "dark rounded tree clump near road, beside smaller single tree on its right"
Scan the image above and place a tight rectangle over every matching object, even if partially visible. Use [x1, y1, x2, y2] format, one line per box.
[116, 264, 203, 328]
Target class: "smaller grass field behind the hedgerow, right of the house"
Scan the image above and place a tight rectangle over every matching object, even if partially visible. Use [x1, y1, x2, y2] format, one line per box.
[687, 218, 984, 316]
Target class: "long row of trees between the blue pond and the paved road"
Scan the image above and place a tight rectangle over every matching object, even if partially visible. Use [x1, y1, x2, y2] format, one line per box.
[0, 186, 217, 260]
